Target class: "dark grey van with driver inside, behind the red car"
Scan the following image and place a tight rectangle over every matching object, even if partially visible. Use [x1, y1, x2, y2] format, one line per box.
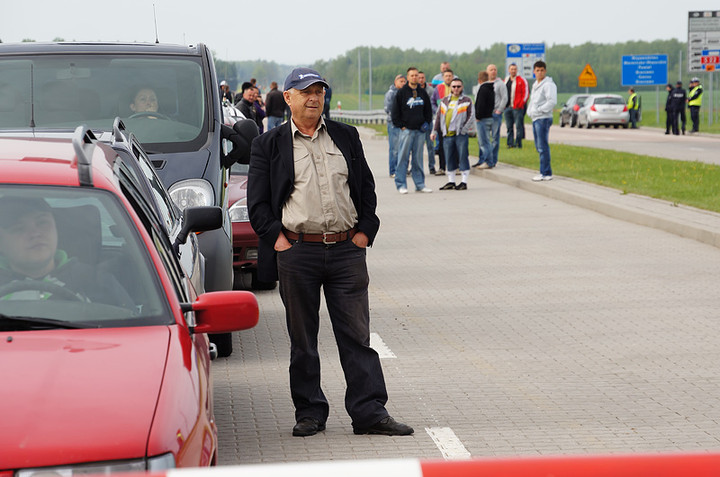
[0, 42, 257, 356]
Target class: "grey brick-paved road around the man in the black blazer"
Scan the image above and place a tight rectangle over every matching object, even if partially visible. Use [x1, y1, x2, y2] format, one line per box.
[213, 128, 720, 465]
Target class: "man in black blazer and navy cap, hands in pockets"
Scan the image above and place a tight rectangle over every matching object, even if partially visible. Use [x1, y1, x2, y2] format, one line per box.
[248, 68, 413, 436]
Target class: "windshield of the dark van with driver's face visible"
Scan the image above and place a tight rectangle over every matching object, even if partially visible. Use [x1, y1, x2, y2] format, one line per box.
[0, 54, 208, 152]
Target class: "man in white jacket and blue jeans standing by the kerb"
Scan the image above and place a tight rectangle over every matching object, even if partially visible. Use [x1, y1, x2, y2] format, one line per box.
[528, 61, 557, 182]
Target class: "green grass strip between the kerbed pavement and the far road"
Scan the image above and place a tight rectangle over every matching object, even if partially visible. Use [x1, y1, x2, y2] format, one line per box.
[364, 124, 720, 212]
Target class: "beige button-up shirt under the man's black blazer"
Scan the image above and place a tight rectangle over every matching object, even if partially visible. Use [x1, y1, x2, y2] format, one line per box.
[282, 118, 358, 234]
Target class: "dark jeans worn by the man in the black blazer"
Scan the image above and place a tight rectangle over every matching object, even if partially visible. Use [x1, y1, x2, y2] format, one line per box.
[277, 240, 388, 427]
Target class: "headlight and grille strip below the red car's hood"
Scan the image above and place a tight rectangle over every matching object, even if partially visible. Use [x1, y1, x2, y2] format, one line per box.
[15, 454, 175, 477]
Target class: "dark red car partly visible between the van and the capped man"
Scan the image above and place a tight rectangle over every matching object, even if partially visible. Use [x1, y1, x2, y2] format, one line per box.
[228, 163, 277, 290]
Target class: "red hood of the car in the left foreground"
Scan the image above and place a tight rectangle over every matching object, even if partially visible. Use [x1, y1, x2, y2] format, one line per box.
[0, 326, 170, 470]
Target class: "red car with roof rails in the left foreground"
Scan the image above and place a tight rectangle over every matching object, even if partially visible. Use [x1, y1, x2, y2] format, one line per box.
[0, 127, 258, 477]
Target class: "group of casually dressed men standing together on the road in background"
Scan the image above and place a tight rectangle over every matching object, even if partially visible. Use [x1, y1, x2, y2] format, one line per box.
[384, 61, 557, 194]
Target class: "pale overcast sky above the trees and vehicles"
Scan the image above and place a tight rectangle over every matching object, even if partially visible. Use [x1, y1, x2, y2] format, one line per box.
[0, 0, 720, 65]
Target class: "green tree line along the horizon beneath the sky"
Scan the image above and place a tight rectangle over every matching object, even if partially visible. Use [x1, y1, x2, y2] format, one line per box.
[216, 39, 690, 99]
